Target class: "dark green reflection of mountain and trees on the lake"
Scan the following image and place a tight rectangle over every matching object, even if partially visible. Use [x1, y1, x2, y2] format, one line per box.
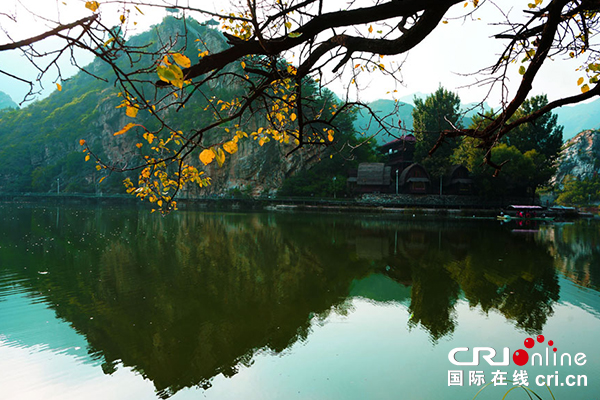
[0, 208, 598, 398]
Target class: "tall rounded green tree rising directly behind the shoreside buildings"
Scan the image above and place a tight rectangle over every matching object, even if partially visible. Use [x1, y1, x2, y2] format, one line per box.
[412, 87, 462, 176]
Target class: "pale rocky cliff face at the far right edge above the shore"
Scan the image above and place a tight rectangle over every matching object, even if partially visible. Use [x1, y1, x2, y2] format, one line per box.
[554, 130, 600, 186]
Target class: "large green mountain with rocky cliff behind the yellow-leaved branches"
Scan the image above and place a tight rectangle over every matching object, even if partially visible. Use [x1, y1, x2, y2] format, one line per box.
[0, 16, 322, 195]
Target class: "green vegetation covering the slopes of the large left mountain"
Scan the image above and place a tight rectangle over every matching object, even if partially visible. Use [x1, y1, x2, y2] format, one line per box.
[0, 17, 232, 192]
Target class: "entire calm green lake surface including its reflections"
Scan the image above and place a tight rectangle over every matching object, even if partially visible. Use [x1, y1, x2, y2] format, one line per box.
[0, 206, 600, 400]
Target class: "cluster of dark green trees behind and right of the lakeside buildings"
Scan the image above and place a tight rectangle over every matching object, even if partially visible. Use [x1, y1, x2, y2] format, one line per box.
[413, 88, 563, 197]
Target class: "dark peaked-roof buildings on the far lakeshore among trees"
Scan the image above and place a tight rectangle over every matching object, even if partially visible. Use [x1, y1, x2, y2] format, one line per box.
[348, 135, 473, 195]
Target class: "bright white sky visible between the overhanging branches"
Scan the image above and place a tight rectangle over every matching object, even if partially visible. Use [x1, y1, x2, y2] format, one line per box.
[0, 0, 592, 107]
